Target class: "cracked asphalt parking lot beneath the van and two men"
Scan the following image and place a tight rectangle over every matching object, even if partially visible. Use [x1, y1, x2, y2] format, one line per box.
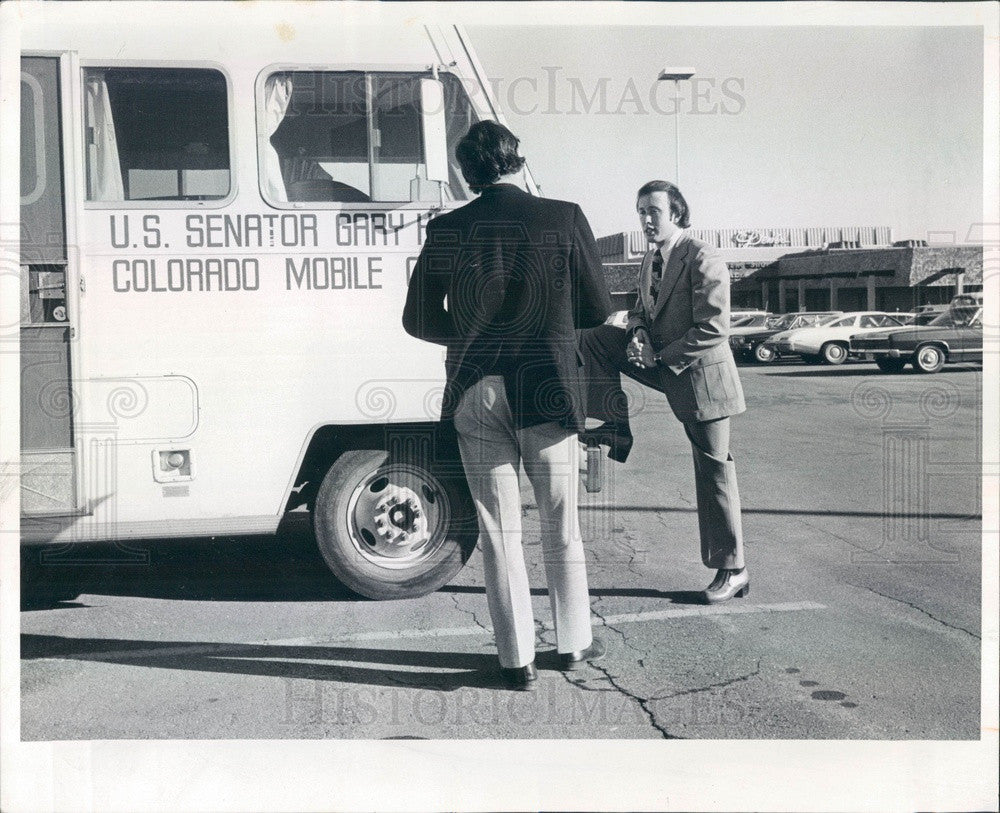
[21, 363, 995, 740]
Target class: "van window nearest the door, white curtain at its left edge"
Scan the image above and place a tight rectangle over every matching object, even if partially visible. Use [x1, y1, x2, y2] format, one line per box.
[84, 68, 230, 201]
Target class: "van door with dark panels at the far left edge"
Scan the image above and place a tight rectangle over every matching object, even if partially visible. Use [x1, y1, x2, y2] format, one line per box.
[20, 56, 79, 515]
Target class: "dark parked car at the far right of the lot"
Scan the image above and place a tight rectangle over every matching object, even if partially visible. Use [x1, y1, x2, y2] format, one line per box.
[850, 294, 983, 373]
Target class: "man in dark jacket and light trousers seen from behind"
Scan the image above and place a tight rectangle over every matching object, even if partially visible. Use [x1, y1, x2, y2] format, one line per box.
[403, 121, 611, 689]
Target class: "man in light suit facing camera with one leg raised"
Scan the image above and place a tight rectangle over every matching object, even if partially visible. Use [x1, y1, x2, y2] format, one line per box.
[580, 181, 750, 604]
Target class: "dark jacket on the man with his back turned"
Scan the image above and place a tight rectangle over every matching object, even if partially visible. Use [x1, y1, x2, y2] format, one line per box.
[403, 184, 611, 431]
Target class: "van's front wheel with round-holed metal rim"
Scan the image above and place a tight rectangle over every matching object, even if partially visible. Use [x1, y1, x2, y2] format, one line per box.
[313, 449, 478, 599]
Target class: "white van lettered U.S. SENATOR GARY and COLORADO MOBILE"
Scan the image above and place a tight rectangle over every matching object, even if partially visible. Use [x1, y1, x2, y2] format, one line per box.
[7, 3, 537, 598]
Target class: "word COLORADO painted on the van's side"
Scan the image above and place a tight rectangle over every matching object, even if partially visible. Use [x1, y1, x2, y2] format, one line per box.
[111, 257, 260, 293]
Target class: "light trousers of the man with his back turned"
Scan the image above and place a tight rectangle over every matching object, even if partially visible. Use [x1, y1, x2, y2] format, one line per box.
[455, 376, 593, 669]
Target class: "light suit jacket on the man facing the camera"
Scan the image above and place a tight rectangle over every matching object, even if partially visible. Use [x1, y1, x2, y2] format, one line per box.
[628, 234, 746, 422]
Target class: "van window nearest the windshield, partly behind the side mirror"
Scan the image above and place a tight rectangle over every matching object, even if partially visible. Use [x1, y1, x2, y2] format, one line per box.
[258, 71, 477, 205]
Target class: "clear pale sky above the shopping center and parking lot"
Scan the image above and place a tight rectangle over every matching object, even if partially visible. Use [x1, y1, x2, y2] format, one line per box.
[467, 25, 983, 242]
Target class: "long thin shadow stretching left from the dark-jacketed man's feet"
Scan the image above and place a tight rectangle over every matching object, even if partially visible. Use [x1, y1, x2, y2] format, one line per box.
[21, 635, 558, 691]
